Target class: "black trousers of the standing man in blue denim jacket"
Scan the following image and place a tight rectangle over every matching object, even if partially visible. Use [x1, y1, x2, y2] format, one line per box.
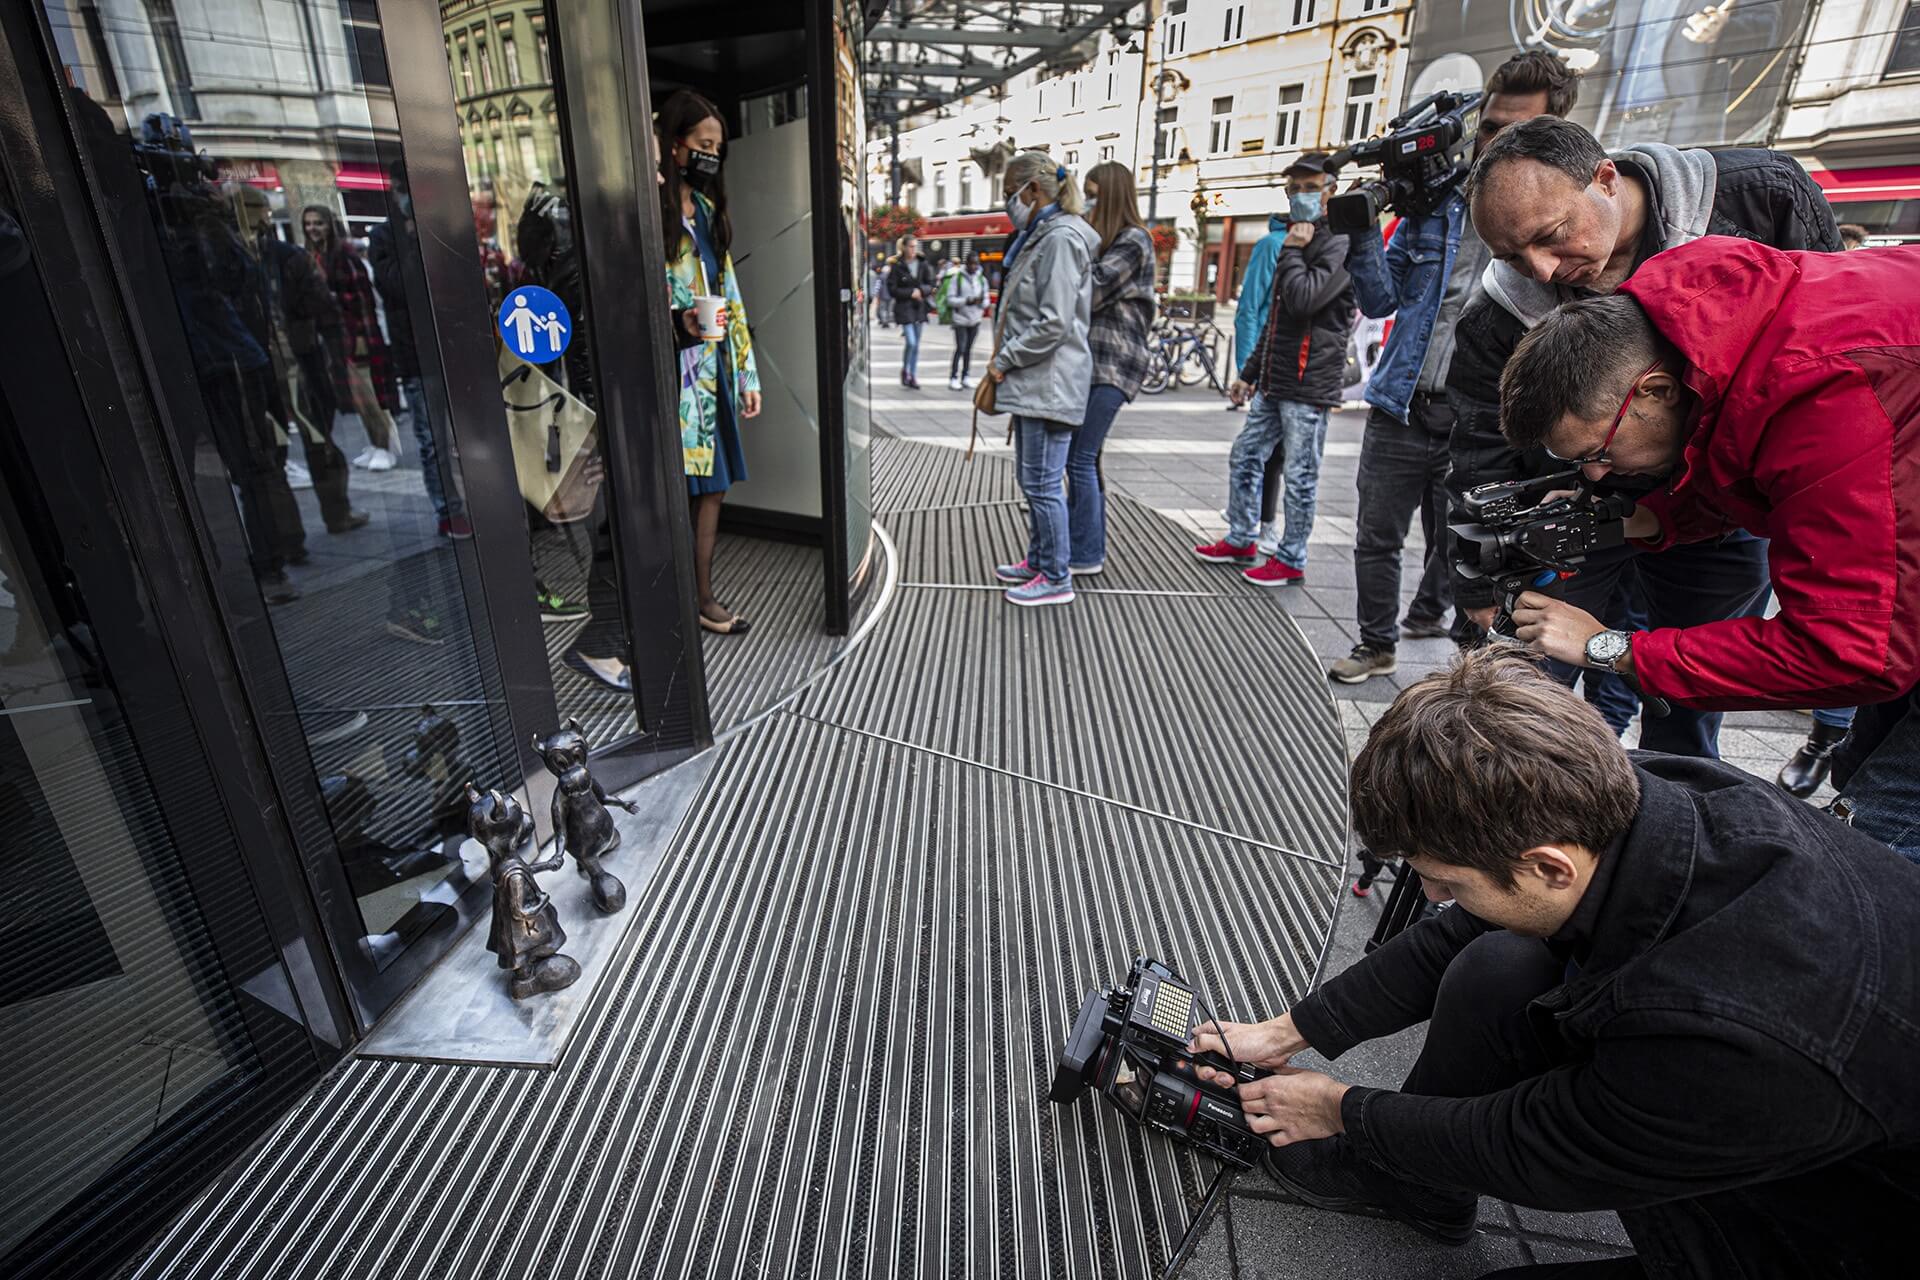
[1354, 391, 1453, 649]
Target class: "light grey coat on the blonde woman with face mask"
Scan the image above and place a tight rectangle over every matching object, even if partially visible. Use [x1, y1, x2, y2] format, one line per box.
[993, 213, 1100, 426]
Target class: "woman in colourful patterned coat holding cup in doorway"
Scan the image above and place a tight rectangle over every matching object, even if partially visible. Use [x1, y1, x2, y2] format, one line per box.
[659, 88, 760, 635]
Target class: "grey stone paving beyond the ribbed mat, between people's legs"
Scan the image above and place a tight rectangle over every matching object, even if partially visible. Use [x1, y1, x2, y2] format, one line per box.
[874, 320, 1832, 1280]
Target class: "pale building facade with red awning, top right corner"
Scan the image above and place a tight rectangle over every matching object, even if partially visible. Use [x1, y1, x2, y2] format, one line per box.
[1774, 0, 1920, 244]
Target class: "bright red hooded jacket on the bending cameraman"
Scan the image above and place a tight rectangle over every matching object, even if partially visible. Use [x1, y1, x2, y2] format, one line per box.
[1620, 236, 1920, 710]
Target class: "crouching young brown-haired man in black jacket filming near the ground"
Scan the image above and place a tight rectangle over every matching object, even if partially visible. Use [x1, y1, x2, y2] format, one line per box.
[1194, 647, 1920, 1276]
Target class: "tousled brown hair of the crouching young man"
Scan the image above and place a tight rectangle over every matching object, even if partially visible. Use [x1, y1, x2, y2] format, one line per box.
[1352, 647, 1640, 889]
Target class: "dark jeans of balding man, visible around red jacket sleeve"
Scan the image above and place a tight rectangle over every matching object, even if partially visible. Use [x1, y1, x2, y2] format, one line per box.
[1548, 533, 1772, 760]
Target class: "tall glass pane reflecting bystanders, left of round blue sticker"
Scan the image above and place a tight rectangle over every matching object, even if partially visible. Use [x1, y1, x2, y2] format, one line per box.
[42, 0, 518, 967]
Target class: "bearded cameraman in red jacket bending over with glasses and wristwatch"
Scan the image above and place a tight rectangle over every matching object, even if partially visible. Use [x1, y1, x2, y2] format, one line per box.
[1500, 236, 1920, 862]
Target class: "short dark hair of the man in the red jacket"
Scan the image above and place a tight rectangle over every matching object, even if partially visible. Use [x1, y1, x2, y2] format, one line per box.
[1500, 294, 1678, 449]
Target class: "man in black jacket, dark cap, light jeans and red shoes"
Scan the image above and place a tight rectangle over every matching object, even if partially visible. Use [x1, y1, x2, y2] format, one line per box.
[1194, 152, 1354, 587]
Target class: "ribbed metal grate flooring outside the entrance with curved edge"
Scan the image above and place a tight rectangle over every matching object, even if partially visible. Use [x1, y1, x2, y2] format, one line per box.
[134, 439, 1346, 1278]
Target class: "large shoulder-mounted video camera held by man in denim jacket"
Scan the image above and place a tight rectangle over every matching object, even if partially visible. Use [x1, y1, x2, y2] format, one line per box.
[1327, 88, 1480, 234]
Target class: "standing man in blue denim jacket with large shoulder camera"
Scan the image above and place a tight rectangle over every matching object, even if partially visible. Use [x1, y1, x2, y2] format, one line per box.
[1329, 50, 1578, 685]
